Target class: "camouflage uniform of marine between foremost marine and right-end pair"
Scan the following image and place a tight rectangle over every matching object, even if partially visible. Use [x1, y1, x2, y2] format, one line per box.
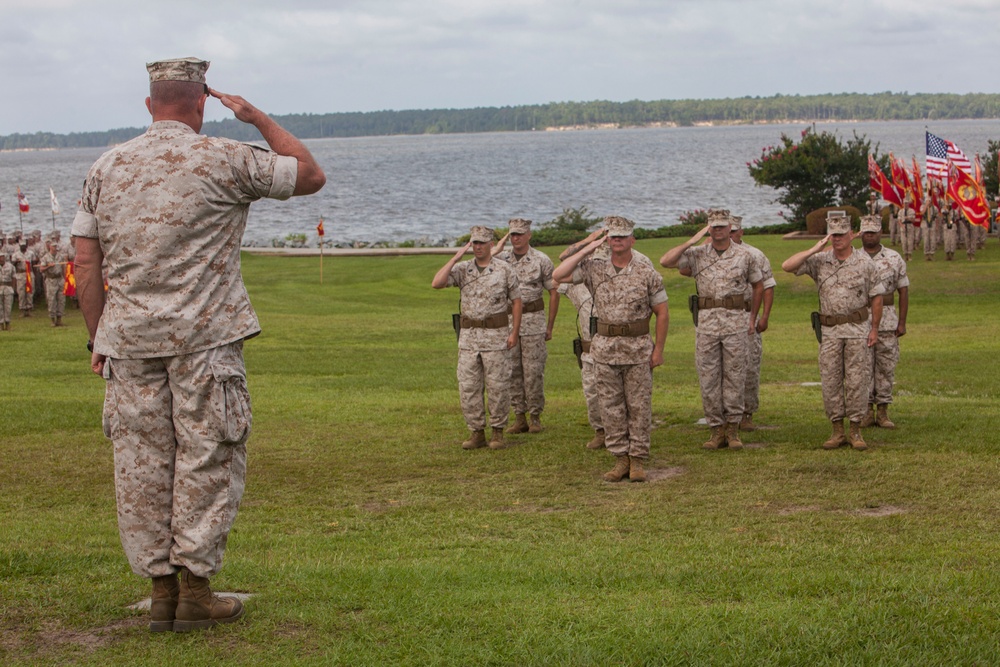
[677, 243, 762, 427]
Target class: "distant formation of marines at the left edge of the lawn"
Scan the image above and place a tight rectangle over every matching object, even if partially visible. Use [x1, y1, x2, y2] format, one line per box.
[0, 230, 74, 331]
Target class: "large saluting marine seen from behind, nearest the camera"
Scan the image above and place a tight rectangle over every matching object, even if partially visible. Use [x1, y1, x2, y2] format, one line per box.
[72, 58, 326, 632]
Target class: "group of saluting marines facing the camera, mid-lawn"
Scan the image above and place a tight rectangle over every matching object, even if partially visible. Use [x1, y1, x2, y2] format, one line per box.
[432, 209, 909, 482]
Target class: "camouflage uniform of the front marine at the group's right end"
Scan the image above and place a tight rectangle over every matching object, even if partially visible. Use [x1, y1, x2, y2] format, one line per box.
[795, 248, 886, 423]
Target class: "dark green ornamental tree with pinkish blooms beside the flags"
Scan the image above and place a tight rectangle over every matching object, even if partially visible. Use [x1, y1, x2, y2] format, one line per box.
[747, 126, 888, 229]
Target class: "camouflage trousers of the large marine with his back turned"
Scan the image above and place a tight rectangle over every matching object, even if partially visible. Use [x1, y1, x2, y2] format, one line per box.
[104, 342, 252, 577]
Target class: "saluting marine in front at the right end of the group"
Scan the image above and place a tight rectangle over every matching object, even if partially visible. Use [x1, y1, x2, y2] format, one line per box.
[781, 211, 885, 450]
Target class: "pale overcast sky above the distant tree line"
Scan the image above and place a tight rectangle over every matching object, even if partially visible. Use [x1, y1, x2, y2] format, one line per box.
[0, 0, 1000, 135]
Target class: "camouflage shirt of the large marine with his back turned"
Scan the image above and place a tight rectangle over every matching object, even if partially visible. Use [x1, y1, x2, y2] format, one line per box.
[73, 121, 298, 359]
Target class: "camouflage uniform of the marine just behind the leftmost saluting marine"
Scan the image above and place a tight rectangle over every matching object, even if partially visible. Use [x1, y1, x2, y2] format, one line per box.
[497, 247, 556, 417]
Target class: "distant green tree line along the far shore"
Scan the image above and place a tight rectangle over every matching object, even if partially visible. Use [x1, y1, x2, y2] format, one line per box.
[0, 92, 1000, 150]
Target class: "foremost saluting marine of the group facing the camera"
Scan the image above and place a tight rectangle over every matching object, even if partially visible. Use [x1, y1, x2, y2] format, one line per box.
[553, 216, 669, 482]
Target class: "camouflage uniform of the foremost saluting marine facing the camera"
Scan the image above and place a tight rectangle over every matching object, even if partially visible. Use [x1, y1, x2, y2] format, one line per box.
[573, 252, 667, 460]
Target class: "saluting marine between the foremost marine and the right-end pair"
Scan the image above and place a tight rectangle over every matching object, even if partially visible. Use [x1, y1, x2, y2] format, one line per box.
[660, 209, 764, 449]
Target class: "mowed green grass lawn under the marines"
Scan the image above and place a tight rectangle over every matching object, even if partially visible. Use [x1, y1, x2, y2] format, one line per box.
[0, 237, 1000, 665]
